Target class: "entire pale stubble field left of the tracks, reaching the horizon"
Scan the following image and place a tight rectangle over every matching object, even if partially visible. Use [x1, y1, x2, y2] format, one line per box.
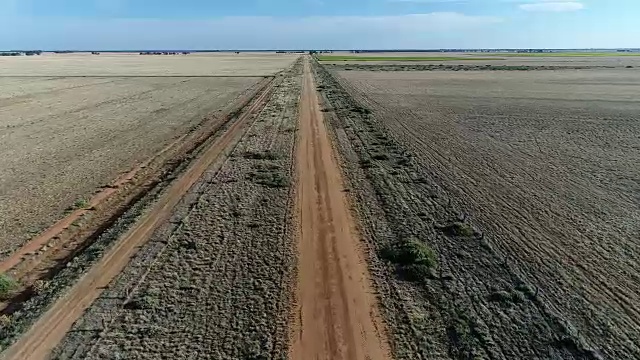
[0, 54, 295, 256]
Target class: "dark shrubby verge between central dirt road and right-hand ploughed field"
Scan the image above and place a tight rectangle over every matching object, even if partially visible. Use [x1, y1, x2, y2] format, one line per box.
[317, 60, 632, 359]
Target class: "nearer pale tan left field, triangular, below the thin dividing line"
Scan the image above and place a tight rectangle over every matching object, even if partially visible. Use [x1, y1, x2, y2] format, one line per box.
[0, 77, 260, 256]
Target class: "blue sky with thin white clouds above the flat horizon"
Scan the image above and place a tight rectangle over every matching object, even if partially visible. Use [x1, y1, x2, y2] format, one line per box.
[0, 0, 640, 50]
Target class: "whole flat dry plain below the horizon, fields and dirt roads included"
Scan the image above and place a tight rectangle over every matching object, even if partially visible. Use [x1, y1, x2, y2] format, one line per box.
[0, 53, 640, 360]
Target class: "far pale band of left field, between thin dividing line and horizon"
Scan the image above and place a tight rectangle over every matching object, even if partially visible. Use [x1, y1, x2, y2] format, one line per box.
[0, 53, 298, 76]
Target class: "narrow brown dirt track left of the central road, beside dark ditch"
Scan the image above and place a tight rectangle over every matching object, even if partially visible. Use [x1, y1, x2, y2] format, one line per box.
[2, 76, 274, 360]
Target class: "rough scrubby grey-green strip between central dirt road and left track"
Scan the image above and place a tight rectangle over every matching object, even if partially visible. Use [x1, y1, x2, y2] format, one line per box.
[54, 64, 301, 359]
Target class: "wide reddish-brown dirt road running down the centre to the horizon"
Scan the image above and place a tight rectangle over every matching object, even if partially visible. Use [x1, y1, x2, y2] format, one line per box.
[290, 59, 389, 360]
